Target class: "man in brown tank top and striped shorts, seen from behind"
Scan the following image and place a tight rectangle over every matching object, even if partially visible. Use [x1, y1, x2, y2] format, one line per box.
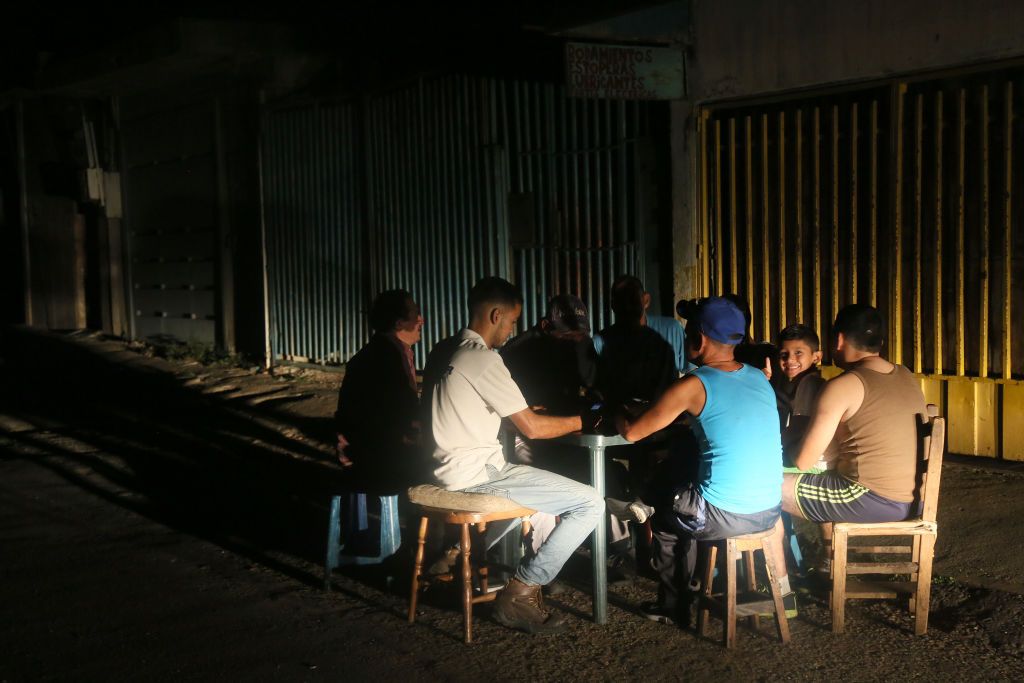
[782, 304, 926, 523]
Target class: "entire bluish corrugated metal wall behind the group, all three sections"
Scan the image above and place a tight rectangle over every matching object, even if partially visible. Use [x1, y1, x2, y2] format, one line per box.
[263, 76, 648, 365]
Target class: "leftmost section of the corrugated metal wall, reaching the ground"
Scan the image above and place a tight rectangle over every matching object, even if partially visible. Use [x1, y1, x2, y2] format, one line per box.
[262, 103, 369, 364]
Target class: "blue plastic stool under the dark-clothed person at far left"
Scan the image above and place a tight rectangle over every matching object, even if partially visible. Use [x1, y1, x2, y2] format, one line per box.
[324, 494, 401, 591]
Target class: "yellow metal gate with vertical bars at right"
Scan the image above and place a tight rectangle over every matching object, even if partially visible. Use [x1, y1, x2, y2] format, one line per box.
[698, 68, 1024, 460]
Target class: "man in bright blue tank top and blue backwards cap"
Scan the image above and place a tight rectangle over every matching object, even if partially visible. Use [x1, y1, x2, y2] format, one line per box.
[618, 297, 791, 626]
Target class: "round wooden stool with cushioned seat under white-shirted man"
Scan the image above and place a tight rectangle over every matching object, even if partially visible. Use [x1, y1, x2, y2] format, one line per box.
[409, 486, 536, 643]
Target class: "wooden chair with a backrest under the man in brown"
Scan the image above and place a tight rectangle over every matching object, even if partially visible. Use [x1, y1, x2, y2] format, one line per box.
[825, 404, 946, 636]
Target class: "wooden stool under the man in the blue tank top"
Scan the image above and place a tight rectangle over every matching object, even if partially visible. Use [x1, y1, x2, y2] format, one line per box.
[697, 519, 790, 648]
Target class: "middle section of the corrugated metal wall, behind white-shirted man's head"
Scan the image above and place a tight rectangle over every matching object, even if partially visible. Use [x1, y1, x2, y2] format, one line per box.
[368, 77, 509, 365]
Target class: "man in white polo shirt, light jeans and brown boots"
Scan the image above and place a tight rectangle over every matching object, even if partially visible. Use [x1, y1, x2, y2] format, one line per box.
[424, 278, 604, 633]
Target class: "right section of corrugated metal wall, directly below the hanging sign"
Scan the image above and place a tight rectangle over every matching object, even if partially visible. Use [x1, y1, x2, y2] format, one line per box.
[501, 82, 650, 331]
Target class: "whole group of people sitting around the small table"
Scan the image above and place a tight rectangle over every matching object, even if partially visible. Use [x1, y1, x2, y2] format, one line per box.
[336, 275, 925, 633]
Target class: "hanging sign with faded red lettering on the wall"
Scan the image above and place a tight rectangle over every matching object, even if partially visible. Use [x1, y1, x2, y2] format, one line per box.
[565, 43, 683, 99]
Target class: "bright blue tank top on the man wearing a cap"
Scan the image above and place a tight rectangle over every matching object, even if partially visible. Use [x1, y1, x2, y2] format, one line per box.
[689, 365, 782, 514]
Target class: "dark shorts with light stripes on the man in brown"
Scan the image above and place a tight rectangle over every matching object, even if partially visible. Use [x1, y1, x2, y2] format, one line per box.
[795, 470, 912, 523]
